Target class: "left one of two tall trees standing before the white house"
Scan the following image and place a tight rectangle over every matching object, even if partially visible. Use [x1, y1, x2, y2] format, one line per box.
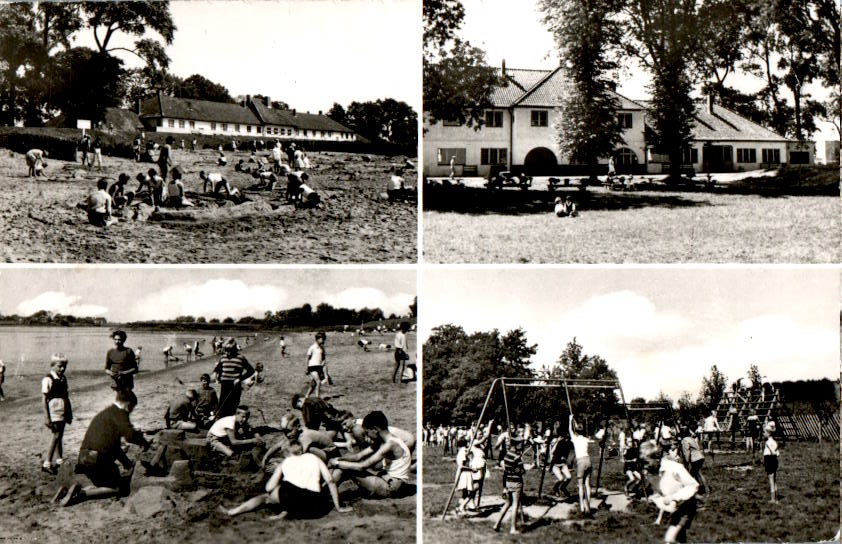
[541, 0, 623, 180]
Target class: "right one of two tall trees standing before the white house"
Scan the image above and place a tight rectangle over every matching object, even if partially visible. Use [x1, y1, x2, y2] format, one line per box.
[625, 0, 698, 181]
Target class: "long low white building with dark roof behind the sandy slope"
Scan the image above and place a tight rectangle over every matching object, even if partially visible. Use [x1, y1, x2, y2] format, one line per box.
[138, 92, 357, 142]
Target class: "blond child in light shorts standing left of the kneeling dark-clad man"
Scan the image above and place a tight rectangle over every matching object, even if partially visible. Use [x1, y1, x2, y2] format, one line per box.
[41, 353, 73, 474]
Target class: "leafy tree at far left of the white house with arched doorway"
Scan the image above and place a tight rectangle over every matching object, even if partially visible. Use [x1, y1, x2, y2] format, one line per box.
[423, 0, 501, 129]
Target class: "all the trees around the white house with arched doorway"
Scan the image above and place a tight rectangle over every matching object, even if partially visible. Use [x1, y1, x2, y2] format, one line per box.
[423, 0, 842, 183]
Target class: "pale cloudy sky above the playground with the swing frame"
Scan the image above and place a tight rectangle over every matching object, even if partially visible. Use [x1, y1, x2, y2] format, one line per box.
[419, 267, 840, 399]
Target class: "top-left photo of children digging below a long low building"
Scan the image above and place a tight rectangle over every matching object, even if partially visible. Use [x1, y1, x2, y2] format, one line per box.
[0, 0, 421, 264]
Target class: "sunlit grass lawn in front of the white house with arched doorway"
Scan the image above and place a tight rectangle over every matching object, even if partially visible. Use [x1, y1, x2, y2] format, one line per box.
[423, 188, 840, 263]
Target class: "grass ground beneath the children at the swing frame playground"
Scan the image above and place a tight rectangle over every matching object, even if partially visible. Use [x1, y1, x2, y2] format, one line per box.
[423, 442, 839, 544]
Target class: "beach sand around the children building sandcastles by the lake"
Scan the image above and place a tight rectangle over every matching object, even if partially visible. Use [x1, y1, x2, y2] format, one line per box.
[0, 333, 416, 543]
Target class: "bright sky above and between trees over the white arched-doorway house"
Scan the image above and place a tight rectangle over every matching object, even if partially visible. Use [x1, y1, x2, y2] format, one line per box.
[459, 0, 839, 157]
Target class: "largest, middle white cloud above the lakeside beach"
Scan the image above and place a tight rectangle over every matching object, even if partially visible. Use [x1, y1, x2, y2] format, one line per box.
[128, 279, 288, 321]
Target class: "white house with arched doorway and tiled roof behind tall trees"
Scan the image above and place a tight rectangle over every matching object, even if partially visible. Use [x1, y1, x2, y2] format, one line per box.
[423, 63, 815, 177]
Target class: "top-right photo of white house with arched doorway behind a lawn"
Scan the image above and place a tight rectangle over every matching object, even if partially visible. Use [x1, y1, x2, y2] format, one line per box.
[422, 0, 841, 263]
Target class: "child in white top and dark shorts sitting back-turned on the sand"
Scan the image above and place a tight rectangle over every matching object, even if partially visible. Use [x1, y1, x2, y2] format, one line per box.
[219, 443, 352, 519]
